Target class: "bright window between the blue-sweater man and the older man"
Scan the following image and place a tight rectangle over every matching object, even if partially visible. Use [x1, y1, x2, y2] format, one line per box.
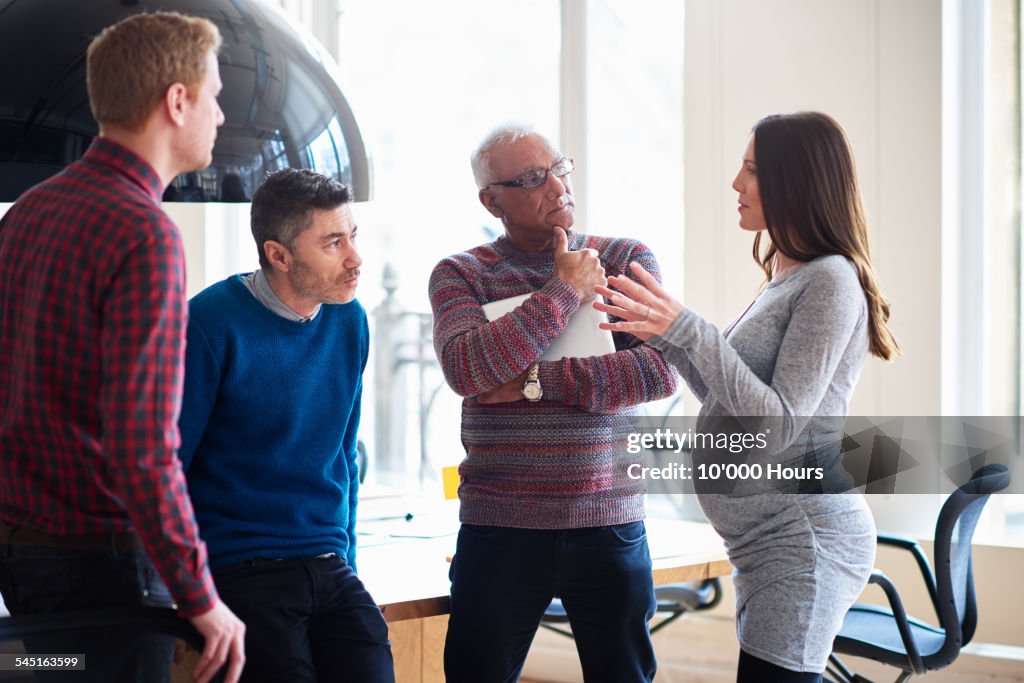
[338, 0, 572, 487]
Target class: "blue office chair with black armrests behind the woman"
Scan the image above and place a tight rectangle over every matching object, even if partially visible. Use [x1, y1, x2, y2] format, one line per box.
[826, 465, 1010, 683]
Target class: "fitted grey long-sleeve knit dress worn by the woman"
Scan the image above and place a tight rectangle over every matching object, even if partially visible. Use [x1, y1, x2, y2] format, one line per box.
[650, 256, 874, 671]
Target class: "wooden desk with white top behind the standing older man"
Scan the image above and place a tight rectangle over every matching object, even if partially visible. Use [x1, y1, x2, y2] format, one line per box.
[358, 511, 732, 683]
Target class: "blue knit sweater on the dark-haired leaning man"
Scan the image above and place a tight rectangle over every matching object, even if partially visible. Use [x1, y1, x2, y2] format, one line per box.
[179, 275, 370, 568]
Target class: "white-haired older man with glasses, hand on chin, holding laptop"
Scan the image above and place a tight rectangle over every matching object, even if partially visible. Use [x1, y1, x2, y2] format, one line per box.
[430, 126, 677, 683]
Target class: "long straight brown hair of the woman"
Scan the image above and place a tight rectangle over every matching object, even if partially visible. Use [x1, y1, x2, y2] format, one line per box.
[754, 112, 900, 360]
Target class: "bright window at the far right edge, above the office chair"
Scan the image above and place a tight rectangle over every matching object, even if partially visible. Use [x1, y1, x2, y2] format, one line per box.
[942, 0, 1024, 545]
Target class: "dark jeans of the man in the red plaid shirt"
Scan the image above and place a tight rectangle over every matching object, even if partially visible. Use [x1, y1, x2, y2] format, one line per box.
[0, 528, 174, 683]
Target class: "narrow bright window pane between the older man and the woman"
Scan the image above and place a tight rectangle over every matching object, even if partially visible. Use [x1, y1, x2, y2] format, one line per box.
[587, 0, 683, 296]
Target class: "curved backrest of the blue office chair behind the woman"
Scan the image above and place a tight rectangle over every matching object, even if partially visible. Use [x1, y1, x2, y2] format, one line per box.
[923, 465, 1010, 669]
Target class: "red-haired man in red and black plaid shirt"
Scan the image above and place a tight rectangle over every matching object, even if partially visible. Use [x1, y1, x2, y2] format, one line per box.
[0, 12, 245, 683]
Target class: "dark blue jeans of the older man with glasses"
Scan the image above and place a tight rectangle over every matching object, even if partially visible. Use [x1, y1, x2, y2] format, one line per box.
[444, 522, 656, 683]
